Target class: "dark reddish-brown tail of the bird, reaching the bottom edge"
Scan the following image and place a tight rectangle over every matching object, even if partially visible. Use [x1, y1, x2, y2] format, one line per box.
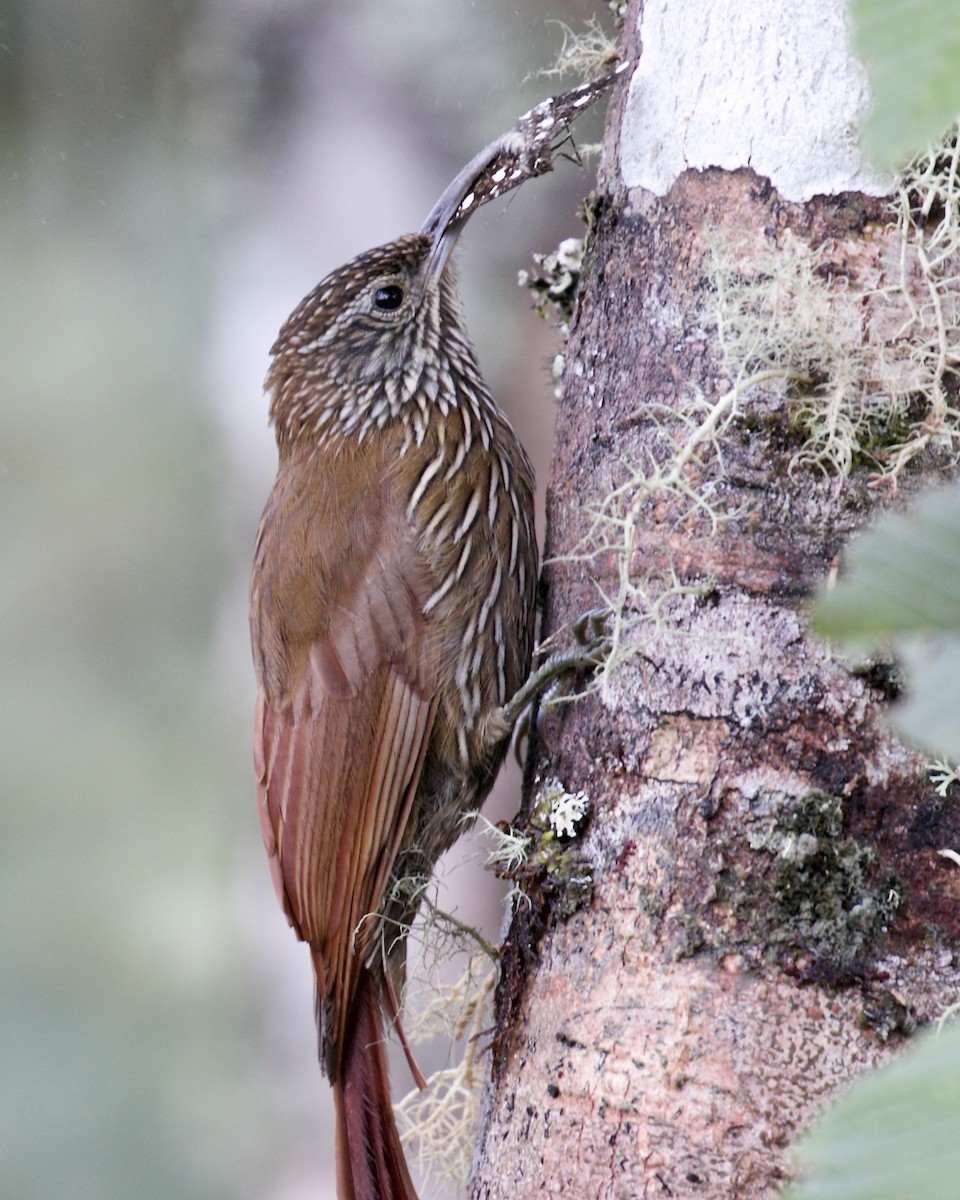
[334, 968, 416, 1200]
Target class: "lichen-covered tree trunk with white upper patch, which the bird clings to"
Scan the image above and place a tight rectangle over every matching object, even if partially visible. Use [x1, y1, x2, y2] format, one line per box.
[472, 0, 960, 1200]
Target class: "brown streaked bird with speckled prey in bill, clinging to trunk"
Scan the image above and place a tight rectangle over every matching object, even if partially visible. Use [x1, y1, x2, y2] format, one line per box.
[251, 76, 614, 1200]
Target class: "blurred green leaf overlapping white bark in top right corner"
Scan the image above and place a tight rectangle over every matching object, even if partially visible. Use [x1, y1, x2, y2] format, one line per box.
[851, 0, 960, 167]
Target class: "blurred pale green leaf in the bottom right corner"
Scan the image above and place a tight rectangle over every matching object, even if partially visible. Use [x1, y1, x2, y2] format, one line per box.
[788, 1027, 960, 1200]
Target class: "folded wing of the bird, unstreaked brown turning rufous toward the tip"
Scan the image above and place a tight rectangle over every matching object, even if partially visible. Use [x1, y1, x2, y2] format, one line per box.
[253, 451, 437, 1070]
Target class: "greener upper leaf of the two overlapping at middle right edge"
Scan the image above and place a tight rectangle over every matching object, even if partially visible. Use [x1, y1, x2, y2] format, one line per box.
[814, 488, 960, 644]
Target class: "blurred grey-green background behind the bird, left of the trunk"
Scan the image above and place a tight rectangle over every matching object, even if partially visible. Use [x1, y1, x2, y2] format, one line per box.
[0, 0, 602, 1200]
